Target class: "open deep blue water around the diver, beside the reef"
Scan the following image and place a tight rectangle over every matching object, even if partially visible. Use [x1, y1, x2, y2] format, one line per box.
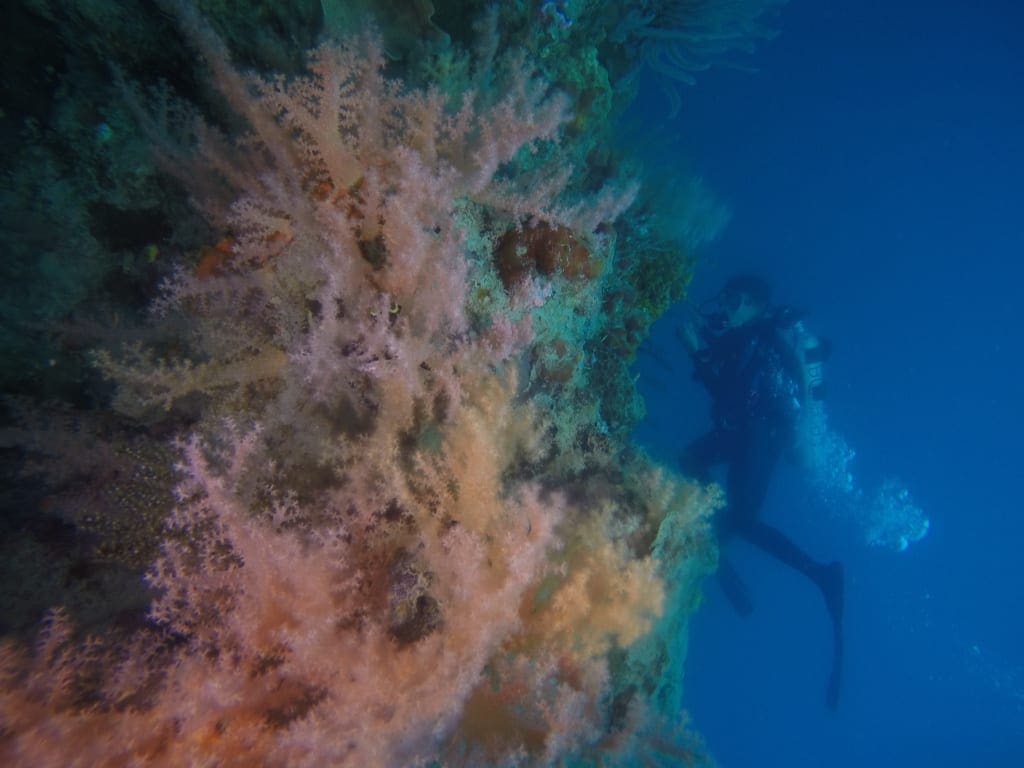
[638, 0, 1024, 768]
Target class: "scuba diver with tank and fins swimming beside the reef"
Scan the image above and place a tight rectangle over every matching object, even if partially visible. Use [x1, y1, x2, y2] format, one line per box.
[678, 275, 843, 710]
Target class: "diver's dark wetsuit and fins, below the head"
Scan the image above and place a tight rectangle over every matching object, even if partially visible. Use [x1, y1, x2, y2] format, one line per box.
[681, 311, 843, 709]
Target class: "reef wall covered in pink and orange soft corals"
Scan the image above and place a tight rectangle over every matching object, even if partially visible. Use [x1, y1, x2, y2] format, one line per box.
[0, 0, 778, 766]
